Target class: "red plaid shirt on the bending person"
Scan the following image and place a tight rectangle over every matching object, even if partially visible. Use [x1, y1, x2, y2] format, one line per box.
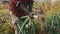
[9, 0, 33, 16]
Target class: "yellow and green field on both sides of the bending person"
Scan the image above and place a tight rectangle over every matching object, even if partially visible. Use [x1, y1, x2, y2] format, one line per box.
[0, 2, 60, 34]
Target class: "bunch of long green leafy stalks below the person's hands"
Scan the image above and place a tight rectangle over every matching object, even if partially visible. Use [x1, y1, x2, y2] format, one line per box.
[17, 16, 35, 34]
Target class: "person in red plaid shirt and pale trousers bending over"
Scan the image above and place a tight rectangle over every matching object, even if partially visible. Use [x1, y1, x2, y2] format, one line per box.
[9, 0, 33, 34]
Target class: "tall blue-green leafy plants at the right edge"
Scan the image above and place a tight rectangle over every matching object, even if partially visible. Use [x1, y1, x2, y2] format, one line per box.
[46, 13, 60, 34]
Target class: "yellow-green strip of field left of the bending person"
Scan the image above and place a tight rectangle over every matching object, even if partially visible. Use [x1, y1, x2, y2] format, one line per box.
[0, 4, 14, 34]
